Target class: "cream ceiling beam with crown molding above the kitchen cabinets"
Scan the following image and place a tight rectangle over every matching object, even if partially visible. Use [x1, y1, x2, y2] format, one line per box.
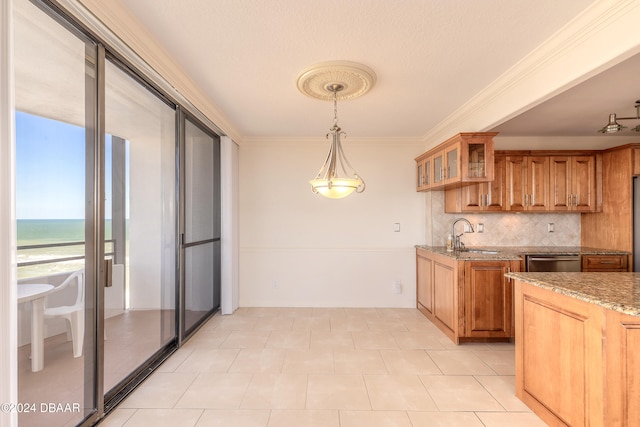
[423, 0, 640, 147]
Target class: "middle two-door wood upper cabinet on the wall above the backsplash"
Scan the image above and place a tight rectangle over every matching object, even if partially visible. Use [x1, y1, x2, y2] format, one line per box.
[505, 156, 549, 212]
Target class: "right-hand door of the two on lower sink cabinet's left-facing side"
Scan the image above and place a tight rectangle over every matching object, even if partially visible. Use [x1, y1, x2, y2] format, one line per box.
[433, 261, 457, 334]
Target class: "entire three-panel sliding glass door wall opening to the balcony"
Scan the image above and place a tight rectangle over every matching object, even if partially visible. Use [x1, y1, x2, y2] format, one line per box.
[13, 0, 221, 427]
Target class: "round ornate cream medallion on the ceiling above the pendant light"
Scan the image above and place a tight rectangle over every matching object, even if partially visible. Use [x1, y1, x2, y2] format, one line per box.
[297, 61, 376, 101]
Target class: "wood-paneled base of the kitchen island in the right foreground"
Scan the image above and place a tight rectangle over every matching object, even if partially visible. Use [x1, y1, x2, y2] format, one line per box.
[515, 281, 640, 426]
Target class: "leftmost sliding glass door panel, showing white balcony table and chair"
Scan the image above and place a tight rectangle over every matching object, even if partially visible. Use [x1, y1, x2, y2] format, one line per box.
[14, 0, 99, 426]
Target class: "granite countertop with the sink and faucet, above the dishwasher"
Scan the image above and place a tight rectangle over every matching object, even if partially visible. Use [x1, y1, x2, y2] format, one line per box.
[416, 245, 631, 261]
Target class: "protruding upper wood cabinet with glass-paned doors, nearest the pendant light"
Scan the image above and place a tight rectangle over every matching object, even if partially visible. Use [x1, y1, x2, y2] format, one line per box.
[415, 132, 497, 191]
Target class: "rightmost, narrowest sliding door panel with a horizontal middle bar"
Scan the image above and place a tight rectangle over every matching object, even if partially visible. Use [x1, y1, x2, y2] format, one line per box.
[180, 118, 220, 337]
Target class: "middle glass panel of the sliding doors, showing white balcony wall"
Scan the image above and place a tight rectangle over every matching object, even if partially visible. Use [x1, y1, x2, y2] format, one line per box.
[103, 58, 176, 401]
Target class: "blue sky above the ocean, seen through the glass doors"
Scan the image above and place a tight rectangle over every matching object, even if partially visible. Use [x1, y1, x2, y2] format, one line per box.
[16, 112, 111, 219]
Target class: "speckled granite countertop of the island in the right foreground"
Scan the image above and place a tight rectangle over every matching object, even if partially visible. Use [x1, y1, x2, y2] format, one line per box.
[506, 273, 640, 317]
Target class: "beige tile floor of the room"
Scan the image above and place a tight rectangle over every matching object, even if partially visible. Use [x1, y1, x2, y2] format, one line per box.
[100, 308, 545, 427]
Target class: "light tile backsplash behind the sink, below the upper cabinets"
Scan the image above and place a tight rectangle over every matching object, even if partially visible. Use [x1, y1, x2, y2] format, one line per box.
[425, 191, 580, 246]
